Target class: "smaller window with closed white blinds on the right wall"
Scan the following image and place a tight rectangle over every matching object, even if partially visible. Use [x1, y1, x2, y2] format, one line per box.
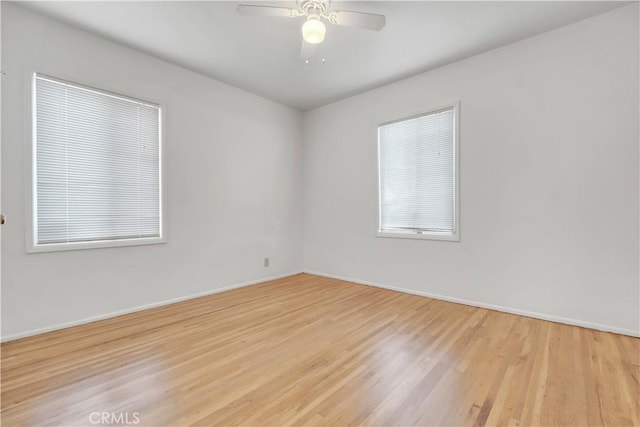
[378, 105, 459, 240]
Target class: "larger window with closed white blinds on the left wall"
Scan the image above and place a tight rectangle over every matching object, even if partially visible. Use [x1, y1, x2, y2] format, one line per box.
[30, 74, 163, 251]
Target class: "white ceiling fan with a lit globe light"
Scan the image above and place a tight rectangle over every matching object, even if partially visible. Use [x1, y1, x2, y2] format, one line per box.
[236, 0, 386, 58]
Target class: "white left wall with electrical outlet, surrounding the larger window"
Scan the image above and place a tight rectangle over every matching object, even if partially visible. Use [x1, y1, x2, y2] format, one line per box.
[2, 2, 302, 339]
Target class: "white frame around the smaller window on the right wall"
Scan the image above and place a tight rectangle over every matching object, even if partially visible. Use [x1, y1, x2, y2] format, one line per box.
[375, 101, 460, 242]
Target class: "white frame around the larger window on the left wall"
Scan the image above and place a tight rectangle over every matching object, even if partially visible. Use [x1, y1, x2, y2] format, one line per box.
[25, 69, 168, 254]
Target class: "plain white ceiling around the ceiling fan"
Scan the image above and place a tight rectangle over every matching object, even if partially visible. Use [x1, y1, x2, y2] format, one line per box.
[20, 0, 627, 111]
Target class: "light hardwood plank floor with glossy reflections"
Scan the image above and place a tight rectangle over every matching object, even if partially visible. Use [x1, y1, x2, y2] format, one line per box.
[1, 274, 640, 427]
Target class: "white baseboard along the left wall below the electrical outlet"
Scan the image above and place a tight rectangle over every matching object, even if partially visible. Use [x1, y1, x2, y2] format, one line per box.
[0, 271, 302, 342]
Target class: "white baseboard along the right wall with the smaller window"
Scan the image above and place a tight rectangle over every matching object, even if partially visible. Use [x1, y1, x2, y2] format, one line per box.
[305, 270, 640, 337]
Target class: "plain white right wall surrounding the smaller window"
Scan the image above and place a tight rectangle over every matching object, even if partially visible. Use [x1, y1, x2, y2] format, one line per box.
[302, 4, 640, 334]
